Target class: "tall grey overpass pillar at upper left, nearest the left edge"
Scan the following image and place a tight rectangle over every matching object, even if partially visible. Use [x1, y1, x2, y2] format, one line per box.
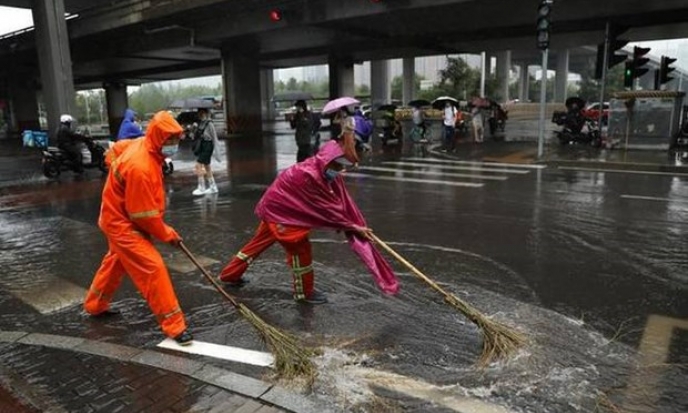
[31, 0, 76, 131]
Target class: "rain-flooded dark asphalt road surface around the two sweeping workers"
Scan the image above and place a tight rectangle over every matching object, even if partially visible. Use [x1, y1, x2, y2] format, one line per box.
[0, 123, 688, 413]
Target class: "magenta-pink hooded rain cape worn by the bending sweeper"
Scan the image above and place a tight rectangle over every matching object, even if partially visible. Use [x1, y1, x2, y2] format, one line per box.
[255, 141, 399, 294]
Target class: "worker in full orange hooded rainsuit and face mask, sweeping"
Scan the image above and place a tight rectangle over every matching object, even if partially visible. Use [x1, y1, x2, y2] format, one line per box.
[84, 111, 193, 345]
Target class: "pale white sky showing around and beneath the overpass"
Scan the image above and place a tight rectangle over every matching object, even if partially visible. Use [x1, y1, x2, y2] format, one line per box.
[0, 6, 688, 87]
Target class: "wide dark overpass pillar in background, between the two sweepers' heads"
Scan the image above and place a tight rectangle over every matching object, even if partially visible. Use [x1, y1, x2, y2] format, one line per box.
[222, 45, 263, 134]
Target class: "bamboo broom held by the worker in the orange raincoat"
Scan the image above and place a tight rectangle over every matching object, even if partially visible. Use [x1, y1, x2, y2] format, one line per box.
[179, 242, 316, 386]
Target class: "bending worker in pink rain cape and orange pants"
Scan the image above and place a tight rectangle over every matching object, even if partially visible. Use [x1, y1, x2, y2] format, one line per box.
[220, 141, 399, 304]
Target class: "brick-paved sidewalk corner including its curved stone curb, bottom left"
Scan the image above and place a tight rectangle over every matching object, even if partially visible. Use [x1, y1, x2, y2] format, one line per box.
[0, 331, 329, 413]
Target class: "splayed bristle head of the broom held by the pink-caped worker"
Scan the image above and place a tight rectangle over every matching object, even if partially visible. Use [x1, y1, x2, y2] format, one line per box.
[445, 295, 526, 366]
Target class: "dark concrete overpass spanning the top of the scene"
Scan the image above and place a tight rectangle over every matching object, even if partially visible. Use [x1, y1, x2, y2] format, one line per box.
[0, 0, 688, 134]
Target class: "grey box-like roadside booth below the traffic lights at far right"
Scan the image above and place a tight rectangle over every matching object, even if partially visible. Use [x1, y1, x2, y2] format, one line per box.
[606, 90, 685, 148]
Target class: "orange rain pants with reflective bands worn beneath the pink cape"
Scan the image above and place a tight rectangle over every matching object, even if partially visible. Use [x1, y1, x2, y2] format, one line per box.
[220, 221, 314, 300]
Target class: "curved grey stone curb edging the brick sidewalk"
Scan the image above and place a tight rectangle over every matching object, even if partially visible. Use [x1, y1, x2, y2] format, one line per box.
[0, 331, 332, 413]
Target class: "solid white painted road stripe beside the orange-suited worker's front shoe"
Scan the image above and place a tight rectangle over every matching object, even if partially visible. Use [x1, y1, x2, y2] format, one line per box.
[158, 338, 275, 367]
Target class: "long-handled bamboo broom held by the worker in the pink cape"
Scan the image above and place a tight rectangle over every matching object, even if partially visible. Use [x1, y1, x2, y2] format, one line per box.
[370, 233, 526, 366]
